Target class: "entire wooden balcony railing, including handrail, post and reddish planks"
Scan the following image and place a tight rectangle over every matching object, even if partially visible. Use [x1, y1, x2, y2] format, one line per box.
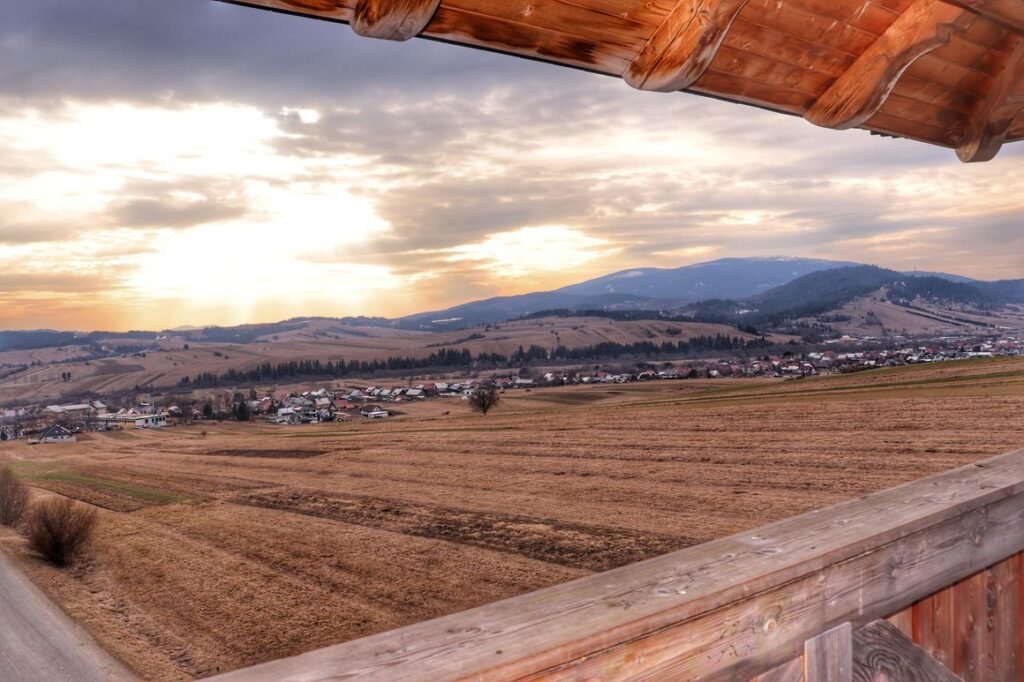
[207, 451, 1024, 682]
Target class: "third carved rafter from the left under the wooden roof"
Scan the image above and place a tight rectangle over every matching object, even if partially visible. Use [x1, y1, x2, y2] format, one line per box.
[804, 0, 975, 130]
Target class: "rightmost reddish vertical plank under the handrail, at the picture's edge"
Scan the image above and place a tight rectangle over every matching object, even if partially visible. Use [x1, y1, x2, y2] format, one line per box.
[991, 554, 1024, 680]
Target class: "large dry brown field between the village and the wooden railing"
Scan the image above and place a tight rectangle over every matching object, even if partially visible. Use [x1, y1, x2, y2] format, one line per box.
[0, 358, 1024, 680]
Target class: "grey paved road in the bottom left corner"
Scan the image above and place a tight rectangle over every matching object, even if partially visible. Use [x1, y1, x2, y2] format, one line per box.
[0, 553, 136, 682]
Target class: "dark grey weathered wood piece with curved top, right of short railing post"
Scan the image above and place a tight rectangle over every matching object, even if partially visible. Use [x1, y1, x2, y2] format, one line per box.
[853, 621, 961, 682]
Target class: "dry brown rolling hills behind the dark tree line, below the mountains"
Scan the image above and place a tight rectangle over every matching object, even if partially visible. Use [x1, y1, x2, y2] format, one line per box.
[0, 317, 770, 404]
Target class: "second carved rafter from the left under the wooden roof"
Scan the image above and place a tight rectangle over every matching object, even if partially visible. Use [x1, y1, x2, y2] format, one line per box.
[623, 0, 748, 92]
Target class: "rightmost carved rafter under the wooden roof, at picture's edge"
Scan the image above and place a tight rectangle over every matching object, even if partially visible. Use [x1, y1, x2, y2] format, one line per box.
[956, 39, 1024, 163]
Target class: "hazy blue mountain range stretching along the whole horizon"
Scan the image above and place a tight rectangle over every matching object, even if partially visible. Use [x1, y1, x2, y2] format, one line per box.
[0, 256, 1007, 350]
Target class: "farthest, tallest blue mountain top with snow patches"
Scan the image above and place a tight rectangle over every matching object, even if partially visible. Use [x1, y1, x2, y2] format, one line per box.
[558, 256, 858, 303]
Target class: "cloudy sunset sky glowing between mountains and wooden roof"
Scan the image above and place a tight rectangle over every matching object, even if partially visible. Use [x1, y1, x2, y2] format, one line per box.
[0, 0, 1024, 330]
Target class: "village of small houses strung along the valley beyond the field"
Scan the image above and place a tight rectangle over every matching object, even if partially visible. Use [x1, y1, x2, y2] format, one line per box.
[0, 336, 1024, 443]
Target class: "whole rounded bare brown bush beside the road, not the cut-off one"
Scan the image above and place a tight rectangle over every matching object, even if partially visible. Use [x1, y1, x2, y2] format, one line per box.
[26, 498, 96, 566]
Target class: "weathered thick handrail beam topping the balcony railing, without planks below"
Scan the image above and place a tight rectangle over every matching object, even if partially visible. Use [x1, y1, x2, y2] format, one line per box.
[205, 451, 1024, 682]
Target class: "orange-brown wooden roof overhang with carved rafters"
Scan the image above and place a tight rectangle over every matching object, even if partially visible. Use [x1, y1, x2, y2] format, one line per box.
[223, 0, 1024, 161]
